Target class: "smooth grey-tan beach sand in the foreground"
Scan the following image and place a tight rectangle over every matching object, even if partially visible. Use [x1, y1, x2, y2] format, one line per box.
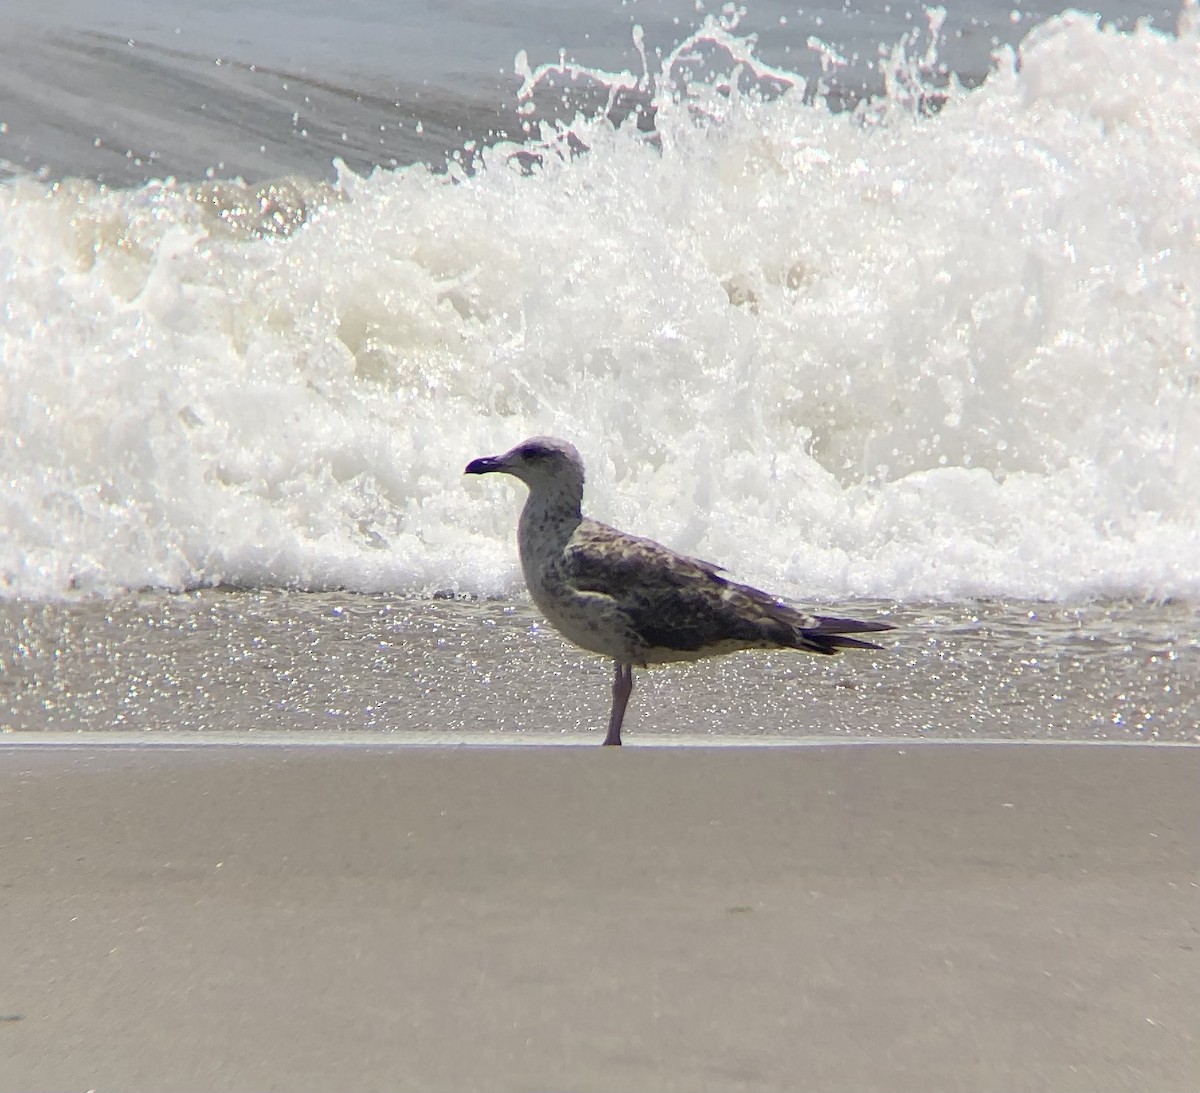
[0, 745, 1200, 1091]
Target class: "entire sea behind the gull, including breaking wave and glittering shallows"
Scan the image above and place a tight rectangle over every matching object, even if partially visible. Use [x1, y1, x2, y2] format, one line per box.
[0, 0, 1200, 741]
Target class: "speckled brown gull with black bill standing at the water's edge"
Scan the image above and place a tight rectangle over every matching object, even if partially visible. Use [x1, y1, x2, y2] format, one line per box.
[464, 437, 892, 745]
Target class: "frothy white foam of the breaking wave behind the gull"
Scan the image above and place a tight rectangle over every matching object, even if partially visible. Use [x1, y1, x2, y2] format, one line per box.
[0, 6, 1200, 599]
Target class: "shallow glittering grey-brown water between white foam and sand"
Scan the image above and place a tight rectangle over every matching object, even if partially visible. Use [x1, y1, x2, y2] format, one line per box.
[0, 589, 1200, 745]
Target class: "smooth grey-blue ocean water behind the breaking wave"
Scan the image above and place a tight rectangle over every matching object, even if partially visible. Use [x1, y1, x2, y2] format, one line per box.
[0, 0, 1181, 186]
